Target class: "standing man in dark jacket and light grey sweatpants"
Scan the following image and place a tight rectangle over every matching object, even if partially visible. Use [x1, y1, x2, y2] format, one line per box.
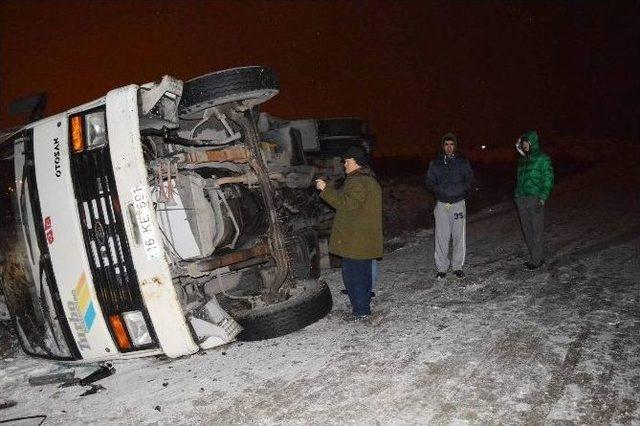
[425, 133, 473, 279]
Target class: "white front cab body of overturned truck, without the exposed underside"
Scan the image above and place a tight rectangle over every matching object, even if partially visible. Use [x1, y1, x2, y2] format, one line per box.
[3, 79, 240, 361]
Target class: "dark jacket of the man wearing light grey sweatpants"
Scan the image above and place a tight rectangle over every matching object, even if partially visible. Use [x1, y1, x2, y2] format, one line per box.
[425, 154, 474, 203]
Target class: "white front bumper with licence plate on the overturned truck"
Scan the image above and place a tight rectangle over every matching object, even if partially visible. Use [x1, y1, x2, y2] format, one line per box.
[106, 85, 199, 358]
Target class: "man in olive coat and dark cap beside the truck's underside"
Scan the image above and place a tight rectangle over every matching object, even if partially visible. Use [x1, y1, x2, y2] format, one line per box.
[316, 147, 382, 319]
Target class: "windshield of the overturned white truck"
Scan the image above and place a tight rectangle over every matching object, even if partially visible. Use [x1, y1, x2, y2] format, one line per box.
[0, 134, 74, 359]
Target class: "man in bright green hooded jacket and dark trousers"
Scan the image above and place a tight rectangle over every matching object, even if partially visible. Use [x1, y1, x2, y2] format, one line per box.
[515, 130, 553, 270]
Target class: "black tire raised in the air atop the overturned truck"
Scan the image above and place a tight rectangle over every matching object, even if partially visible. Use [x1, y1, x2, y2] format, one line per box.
[178, 66, 280, 119]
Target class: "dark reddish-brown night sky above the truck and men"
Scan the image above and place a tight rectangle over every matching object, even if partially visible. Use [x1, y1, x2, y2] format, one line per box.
[0, 1, 640, 156]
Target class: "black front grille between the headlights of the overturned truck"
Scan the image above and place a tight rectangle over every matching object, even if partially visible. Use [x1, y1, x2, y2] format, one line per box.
[71, 146, 155, 349]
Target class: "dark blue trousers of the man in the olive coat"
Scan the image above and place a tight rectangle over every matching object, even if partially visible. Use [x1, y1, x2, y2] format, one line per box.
[342, 257, 373, 315]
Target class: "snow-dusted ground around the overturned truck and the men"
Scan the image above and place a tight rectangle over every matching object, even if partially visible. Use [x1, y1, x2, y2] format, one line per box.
[0, 156, 640, 425]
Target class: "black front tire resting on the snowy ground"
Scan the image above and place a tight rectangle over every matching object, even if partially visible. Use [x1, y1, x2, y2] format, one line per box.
[231, 280, 333, 341]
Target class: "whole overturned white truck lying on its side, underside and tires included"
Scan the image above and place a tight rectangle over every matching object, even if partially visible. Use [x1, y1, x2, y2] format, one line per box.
[0, 67, 350, 362]
